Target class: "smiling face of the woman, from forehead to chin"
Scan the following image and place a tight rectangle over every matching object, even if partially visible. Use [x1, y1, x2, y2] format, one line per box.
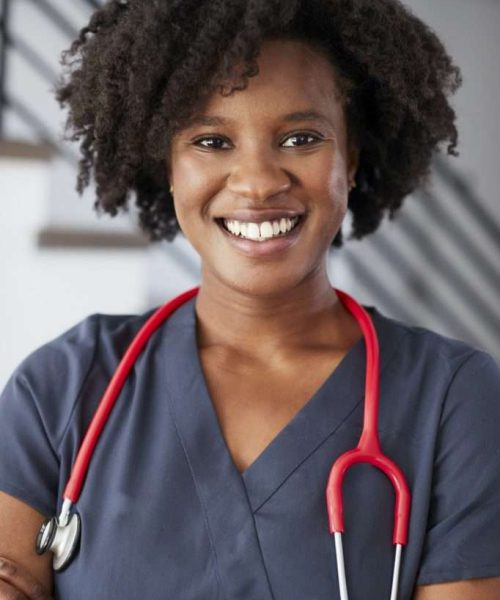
[167, 40, 357, 295]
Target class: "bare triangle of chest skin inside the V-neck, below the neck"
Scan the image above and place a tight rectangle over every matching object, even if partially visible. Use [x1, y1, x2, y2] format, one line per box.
[200, 352, 343, 473]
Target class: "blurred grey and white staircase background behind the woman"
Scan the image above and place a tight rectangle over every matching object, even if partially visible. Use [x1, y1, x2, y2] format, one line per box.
[0, 0, 500, 388]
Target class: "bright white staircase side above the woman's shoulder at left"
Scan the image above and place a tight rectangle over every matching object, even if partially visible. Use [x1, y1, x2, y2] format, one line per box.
[0, 159, 148, 387]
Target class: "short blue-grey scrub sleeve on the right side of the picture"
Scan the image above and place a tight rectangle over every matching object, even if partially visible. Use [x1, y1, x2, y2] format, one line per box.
[417, 351, 500, 585]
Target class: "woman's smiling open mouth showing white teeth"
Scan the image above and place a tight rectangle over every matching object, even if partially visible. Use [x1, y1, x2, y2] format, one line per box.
[215, 215, 304, 243]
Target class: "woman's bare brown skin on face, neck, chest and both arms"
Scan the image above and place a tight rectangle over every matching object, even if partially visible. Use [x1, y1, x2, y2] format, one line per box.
[0, 40, 500, 600]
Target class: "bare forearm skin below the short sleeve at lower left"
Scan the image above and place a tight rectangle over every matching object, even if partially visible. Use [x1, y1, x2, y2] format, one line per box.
[0, 492, 53, 600]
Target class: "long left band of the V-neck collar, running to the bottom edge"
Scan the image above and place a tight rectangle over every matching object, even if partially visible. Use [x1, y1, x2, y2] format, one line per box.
[160, 300, 273, 600]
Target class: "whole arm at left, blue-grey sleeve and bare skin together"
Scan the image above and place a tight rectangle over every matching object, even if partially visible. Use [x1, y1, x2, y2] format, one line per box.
[0, 317, 99, 600]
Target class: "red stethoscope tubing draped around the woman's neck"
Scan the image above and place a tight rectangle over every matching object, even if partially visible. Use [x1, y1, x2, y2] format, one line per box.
[64, 287, 411, 545]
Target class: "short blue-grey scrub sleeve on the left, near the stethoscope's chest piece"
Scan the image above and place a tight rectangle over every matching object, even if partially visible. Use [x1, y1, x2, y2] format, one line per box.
[0, 315, 96, 516]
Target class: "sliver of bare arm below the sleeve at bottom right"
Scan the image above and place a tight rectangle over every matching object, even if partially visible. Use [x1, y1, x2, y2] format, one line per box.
[413, 577, 500, 600]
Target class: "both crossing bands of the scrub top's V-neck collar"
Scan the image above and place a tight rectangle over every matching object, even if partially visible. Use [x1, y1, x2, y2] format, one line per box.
[158, 299, 397, 600]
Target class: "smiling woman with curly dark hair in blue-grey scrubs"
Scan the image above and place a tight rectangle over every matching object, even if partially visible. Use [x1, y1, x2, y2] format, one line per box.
[0, 0, 500, 600]
